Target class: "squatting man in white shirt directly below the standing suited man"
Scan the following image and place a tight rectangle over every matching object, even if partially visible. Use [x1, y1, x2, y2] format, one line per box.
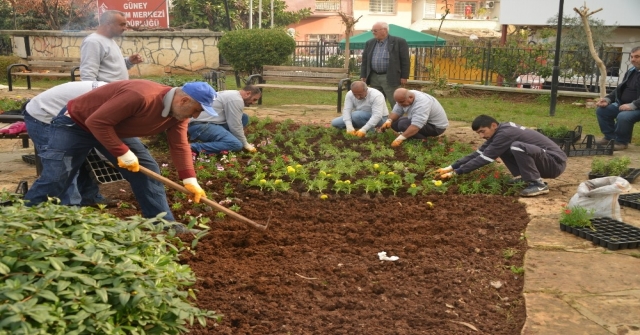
[331, 81, 389, 137]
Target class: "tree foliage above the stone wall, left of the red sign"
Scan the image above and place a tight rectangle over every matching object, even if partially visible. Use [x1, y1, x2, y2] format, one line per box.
[0, 0, 97, 30]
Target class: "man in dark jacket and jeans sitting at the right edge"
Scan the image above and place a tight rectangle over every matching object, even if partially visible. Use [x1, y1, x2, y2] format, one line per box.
[596, 47, 640, 151]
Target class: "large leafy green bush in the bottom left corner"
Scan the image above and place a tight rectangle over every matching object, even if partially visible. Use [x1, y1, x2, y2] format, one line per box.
[0, 194, 220, 335]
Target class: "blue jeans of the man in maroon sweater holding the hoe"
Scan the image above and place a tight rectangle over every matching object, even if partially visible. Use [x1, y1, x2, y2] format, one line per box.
[24, 116, 175, 221]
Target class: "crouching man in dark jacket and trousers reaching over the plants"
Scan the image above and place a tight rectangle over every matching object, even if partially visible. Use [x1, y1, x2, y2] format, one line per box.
[436, 115, 567, 197]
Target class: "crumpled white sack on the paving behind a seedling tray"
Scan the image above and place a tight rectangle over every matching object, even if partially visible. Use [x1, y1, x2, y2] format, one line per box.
[568, 177, 631, 221]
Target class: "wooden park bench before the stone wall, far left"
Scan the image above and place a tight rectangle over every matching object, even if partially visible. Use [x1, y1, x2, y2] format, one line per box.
[7, 56, 80, 91]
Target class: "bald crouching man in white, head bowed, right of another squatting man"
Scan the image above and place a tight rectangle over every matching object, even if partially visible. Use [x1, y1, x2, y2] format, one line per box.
[380, 88, 449, 147]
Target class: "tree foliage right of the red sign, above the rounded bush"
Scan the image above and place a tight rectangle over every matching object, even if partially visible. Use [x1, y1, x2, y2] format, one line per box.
[170, 0, 311, 31]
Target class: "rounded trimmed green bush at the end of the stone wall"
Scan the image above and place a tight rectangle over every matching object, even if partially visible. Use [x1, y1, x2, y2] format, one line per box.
[218, 29, 296, 74]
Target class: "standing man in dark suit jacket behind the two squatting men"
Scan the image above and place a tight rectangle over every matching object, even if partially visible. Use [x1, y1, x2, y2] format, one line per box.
[360, 22, 409, 106]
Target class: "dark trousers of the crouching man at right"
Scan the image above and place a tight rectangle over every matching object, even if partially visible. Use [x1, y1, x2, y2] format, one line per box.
[500, 141, 567, 182]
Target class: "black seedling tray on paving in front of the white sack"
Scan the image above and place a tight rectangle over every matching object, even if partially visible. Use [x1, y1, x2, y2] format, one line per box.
[560, 217, 640, 250]
